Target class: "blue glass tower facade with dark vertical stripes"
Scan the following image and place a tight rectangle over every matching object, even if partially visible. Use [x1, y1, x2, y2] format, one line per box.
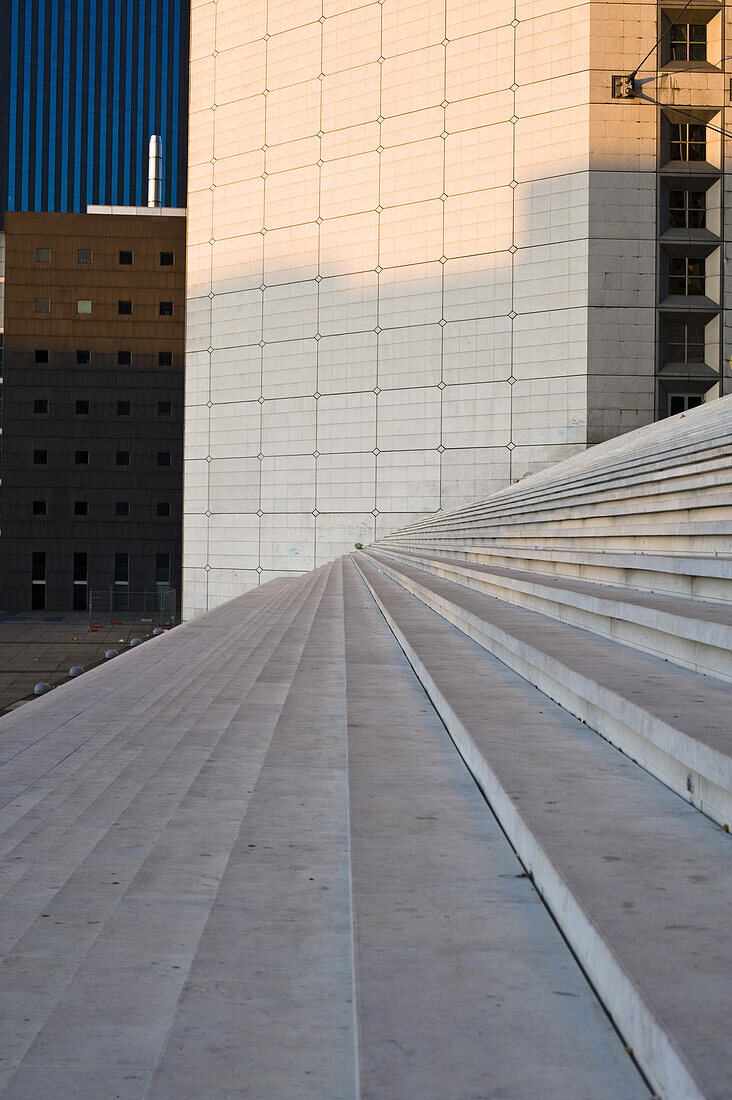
[0, 0, 189, 218]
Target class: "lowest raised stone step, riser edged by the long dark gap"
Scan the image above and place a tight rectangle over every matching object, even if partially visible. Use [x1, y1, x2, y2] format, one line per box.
[357, 554, 732, 1100]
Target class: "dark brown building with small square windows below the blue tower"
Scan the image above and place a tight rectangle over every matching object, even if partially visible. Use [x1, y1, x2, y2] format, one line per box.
[0, 211, 185, 612]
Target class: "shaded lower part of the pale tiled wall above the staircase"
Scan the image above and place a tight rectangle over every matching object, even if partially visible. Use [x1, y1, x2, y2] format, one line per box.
[184, 173, 655, 605]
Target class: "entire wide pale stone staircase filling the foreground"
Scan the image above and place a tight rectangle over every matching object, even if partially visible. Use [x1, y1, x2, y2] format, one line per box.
[0, 399, 732, 1100]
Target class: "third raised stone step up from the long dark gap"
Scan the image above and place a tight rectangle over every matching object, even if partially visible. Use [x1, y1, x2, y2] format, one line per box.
[374, 550, 732, 683]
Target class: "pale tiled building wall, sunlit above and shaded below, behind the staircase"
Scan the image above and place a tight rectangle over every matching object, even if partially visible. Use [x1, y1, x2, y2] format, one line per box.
[184, 0, 721, 615]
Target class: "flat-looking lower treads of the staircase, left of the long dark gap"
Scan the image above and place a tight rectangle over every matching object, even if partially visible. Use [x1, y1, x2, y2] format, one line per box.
[0, 561, 647, 1100]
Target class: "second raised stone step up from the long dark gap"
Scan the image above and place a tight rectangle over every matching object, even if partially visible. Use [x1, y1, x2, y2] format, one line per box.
[359, 551, 732, 825]
